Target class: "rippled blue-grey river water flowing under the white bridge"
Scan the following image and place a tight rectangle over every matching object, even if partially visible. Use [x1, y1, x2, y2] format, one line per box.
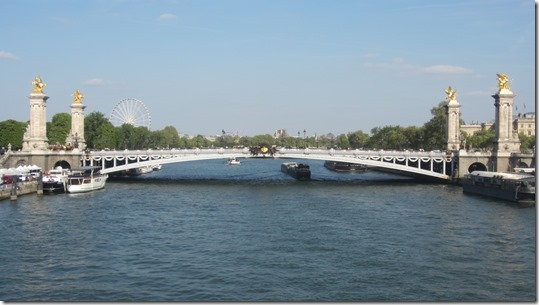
[0, 159, 537, 302]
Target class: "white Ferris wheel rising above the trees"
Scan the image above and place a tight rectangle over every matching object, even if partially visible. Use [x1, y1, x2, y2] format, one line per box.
[109, 98, 152, 129]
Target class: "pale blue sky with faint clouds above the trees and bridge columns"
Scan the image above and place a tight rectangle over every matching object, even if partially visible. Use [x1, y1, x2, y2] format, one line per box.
[0, 0, 536, 136]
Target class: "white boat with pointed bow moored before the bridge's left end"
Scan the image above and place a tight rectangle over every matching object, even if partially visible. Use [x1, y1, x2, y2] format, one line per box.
[67, 166, 109, 193]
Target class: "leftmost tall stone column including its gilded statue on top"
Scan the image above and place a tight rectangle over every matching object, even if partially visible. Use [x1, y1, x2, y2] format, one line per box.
[22, 76, 49, 151]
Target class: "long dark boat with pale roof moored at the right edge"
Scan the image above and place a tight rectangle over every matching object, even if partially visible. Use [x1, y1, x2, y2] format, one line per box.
[462, 171, 535, 204]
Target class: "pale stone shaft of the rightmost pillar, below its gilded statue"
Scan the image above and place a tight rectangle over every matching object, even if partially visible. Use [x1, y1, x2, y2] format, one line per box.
[492, 89, 520, 153]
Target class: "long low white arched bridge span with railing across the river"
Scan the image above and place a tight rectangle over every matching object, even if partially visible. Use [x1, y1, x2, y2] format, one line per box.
[81, 148, 457, 182]
